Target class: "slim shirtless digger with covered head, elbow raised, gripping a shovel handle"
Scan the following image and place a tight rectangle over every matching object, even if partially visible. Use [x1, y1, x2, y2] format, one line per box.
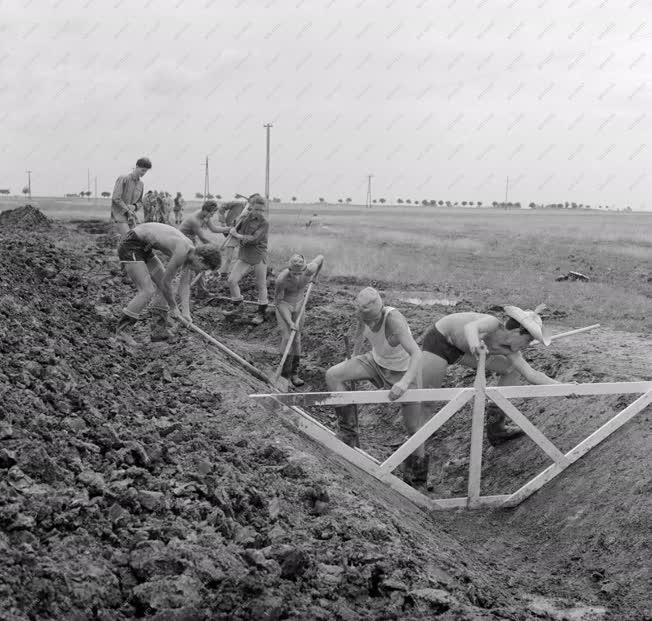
[274, 254, 324, 386]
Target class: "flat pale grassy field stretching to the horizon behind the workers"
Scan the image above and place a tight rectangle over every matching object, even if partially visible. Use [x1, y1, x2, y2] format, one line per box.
[0, 199, 652, 332]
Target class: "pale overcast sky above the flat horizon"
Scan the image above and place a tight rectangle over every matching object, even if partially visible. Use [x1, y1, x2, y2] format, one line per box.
[0, 0, 652, 209]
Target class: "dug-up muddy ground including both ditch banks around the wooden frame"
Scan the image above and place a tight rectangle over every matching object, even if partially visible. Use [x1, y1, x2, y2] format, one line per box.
[0, 213, 652, 620]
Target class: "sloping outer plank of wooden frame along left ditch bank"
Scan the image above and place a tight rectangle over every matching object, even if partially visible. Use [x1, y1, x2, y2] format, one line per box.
[260, 395, 440, 510]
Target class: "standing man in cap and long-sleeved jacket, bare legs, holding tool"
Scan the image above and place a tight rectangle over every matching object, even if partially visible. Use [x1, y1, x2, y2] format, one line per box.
[224, 195, 269, 325]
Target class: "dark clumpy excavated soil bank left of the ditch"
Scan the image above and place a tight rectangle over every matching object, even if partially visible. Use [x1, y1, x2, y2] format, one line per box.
[0, 224, 532, 621]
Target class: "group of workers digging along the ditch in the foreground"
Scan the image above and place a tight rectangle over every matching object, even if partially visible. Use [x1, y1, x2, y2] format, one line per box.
[111, 158, 559, 489]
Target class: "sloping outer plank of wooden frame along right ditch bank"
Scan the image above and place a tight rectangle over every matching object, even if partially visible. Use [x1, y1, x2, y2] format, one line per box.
[503, 390, 652, 507]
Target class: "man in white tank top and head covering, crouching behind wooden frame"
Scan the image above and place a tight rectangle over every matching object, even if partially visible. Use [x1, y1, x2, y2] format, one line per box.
[326, 287, 429, 487]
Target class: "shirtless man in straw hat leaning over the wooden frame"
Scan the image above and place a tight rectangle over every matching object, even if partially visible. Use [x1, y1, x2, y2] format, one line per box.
[422, 304, 560, 446]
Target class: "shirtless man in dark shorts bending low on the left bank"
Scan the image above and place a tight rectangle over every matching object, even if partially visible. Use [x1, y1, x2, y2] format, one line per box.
[116, 222, 221, 345]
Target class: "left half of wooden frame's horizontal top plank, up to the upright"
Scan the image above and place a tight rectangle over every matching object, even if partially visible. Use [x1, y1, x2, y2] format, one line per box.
[249, 388, 473, 407]
